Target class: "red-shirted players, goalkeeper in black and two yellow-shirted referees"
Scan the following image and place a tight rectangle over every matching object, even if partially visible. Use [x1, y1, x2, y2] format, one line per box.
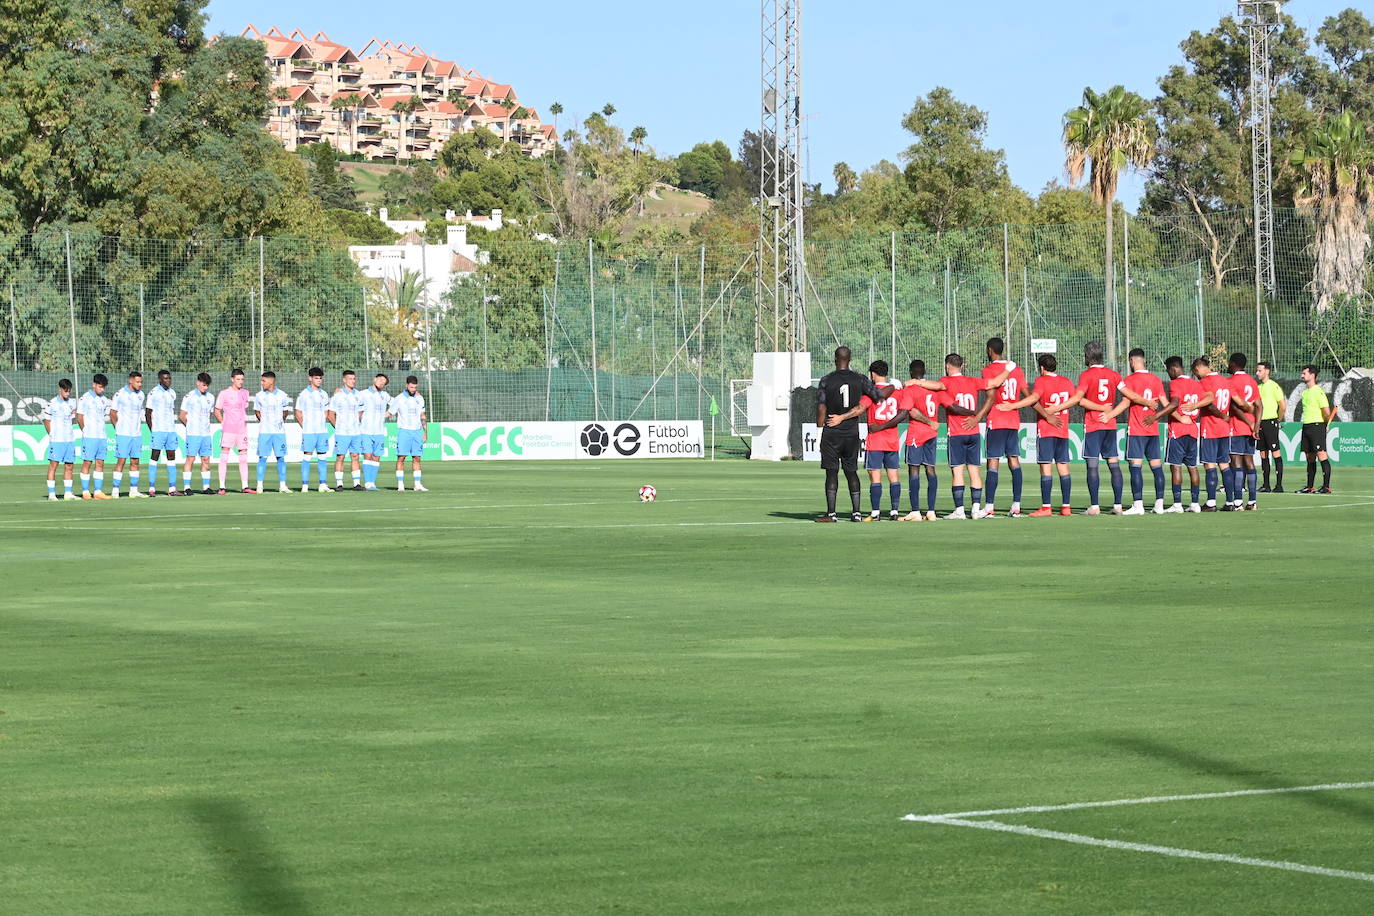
[816, 338, 1334, 522]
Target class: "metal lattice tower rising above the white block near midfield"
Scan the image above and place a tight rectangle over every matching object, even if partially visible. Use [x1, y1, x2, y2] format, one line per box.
[754, 0, 807, 353]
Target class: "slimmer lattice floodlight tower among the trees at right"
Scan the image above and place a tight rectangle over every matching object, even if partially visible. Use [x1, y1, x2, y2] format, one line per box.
[1238, 0, 1283, 356]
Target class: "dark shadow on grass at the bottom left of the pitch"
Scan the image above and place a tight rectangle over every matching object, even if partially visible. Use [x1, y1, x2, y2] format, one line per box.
[187, 798, 311, 916]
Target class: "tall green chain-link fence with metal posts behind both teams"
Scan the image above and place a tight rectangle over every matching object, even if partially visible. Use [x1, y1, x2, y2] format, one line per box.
[0, 211, 1374, 424]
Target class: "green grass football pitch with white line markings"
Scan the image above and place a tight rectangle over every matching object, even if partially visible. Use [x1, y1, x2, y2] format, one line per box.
[0, 461, 1374, 916]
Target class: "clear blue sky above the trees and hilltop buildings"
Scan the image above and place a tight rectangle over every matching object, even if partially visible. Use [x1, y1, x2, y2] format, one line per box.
[209, 0, 1360, 207]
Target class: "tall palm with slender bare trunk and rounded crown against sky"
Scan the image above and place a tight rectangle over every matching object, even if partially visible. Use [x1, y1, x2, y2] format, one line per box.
[1063, 87, 1158, 365]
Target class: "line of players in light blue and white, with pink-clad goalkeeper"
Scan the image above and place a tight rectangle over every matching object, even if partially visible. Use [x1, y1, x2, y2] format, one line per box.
[43, 368, 427, 500]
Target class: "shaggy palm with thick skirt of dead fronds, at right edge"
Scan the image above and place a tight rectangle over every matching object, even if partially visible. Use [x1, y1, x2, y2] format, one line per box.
[1292, 111, 1374, 314]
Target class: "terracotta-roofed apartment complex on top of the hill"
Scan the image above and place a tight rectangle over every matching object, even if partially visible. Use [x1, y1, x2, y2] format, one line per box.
[242, 25, 558, 162]
